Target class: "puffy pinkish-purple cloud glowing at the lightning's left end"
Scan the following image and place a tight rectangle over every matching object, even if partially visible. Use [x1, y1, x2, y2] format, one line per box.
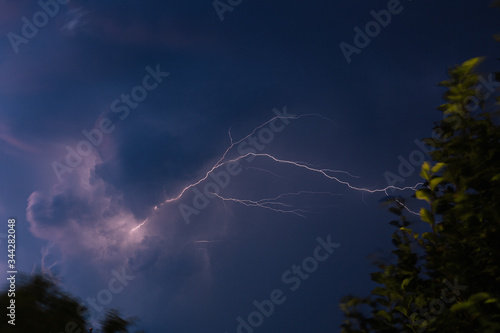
[27, 157, 144, 260]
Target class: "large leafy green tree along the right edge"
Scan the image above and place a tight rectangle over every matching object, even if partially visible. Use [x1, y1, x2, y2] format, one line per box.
[341, 54, 500, 333]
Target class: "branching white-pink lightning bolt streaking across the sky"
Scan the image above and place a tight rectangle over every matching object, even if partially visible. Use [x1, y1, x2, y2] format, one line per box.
[130, 113, 423, 232]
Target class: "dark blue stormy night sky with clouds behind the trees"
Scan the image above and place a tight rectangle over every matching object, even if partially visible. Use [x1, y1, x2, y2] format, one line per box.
[0, 0, 500, 333]
